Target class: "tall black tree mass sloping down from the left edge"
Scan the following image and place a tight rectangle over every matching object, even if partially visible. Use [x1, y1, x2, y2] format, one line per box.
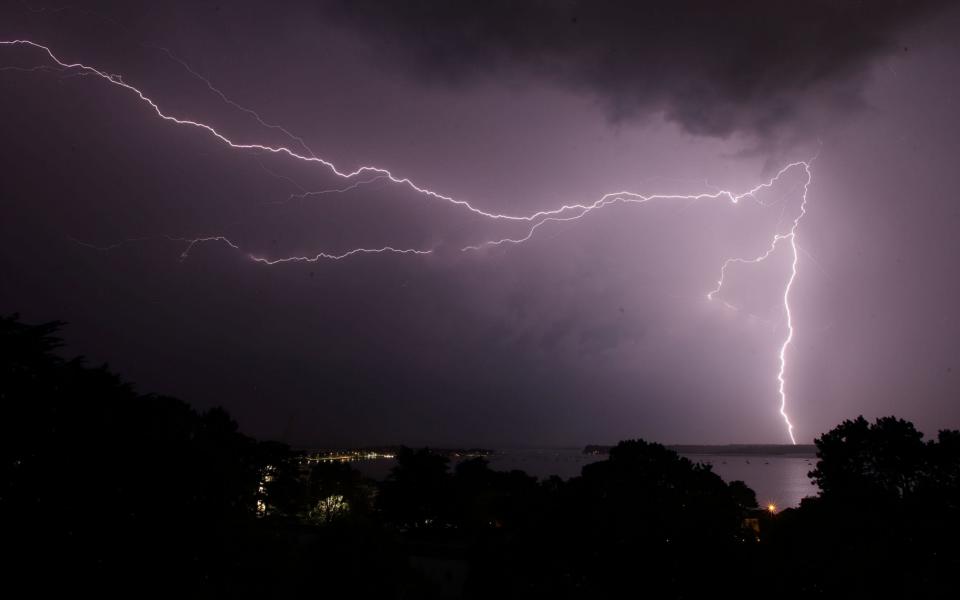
[0, 317, 409, 597]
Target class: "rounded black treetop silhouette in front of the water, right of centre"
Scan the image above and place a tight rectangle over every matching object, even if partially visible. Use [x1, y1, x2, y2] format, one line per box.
[466, 440, 755, 598]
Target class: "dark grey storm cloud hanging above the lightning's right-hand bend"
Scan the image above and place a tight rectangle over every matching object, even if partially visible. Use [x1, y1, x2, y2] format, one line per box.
[323, 0, 947, 137]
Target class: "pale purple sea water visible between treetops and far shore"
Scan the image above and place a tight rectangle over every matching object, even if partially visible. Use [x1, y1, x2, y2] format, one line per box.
[351, 446, 818, 510]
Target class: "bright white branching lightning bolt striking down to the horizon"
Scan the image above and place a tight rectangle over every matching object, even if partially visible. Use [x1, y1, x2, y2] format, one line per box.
[0, 39, 816, 444]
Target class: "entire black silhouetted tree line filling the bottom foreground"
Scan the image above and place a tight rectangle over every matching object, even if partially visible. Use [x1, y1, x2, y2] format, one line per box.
[0, 318, 960, 598]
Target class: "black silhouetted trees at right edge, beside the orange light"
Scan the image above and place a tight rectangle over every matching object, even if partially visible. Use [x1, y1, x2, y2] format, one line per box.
[763, 417, 960, 598]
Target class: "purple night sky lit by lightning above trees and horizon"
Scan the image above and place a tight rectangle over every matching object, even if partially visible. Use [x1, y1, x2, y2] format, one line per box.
[0, 0, 960, 446]
